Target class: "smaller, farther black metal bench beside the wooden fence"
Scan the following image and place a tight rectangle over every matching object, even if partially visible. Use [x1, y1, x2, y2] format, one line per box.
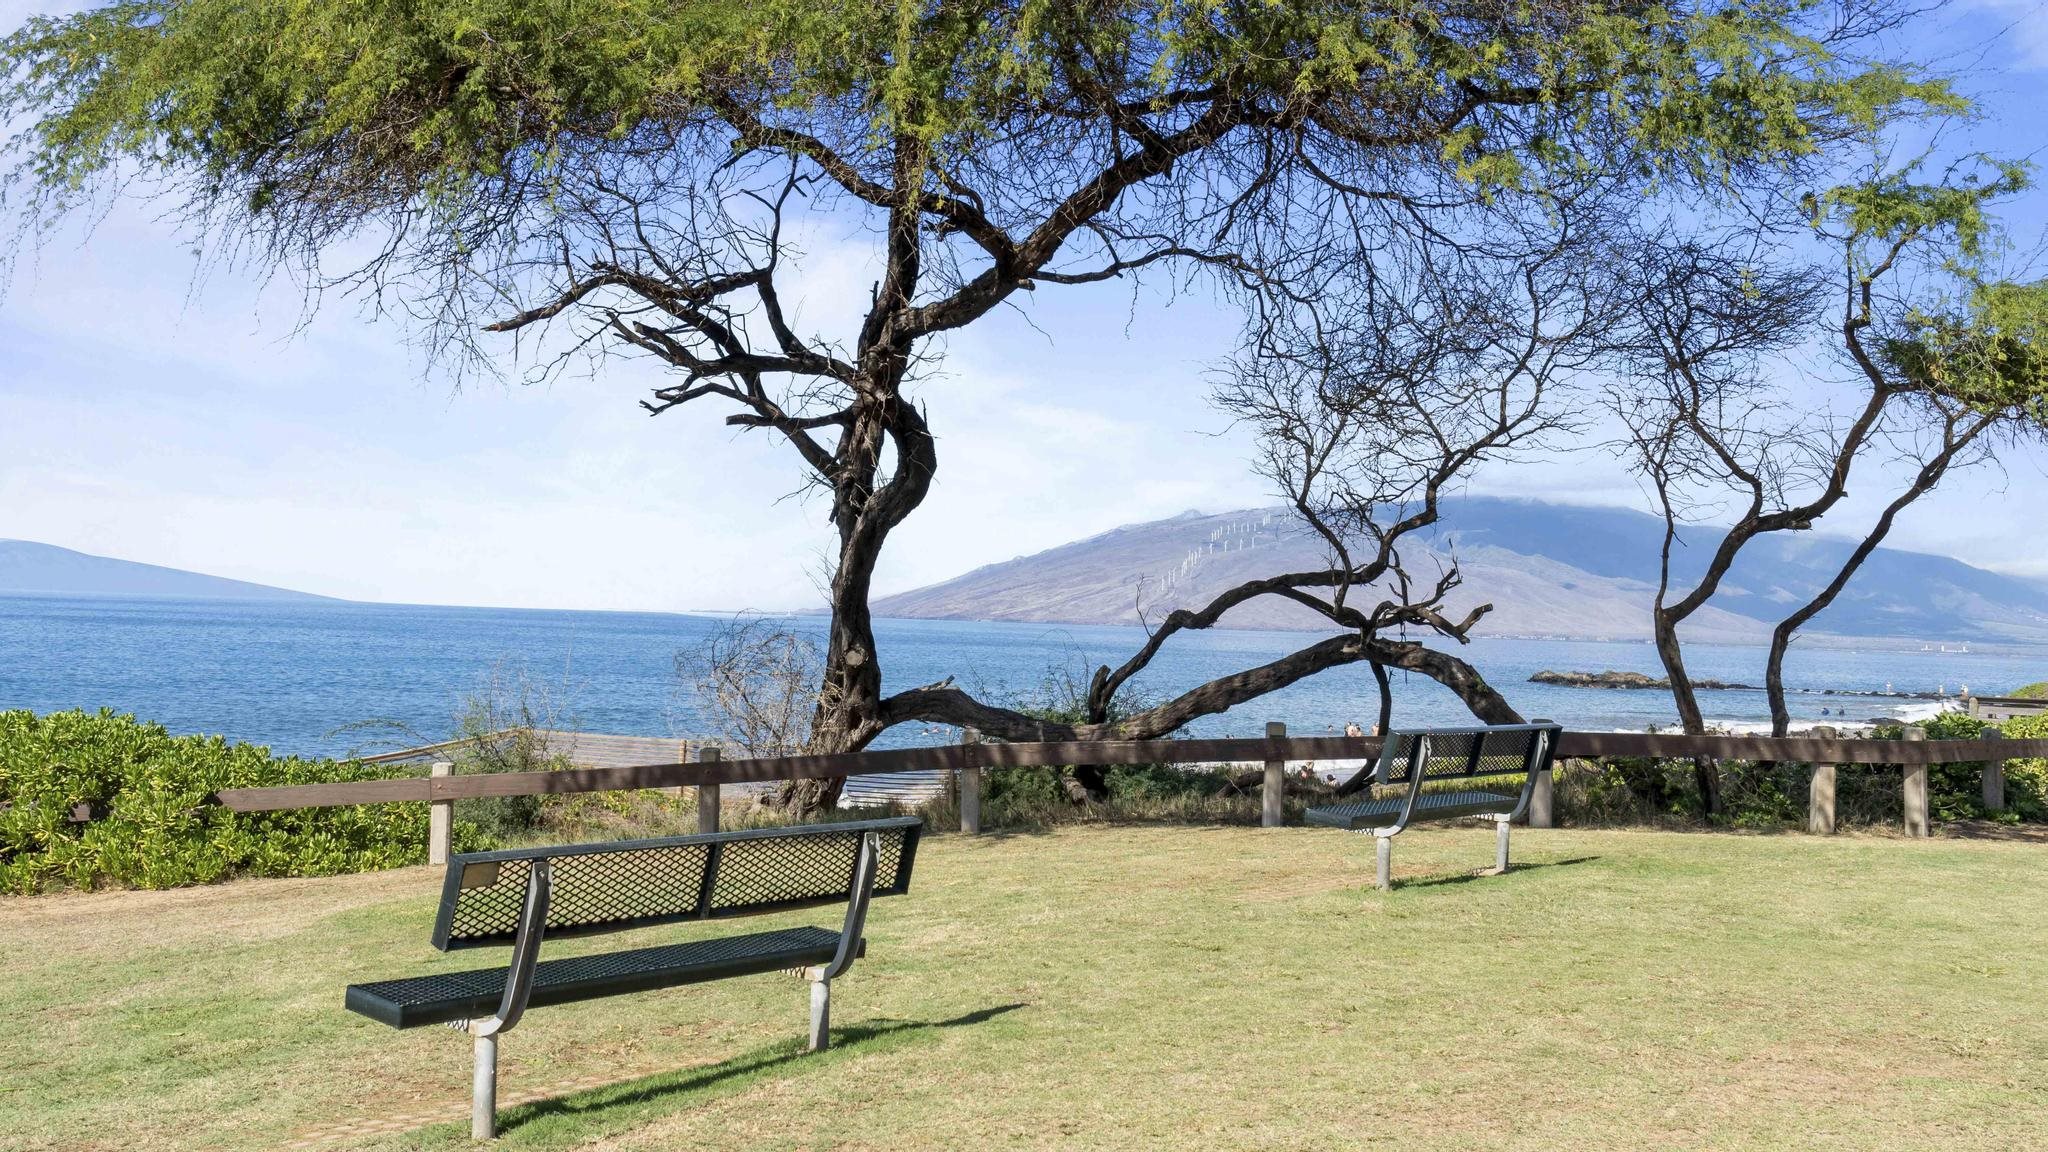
[1305, 722, 1563, 892]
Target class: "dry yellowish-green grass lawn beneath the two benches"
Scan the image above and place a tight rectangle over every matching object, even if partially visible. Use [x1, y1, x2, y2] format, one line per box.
[0, 824, 2048, 1152]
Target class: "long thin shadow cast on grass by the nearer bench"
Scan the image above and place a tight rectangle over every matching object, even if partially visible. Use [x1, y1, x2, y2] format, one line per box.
[498, 1004, 1026, 1136]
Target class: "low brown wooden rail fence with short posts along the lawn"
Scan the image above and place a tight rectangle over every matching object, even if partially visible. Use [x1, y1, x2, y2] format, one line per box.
[213, 724, 2048, 861]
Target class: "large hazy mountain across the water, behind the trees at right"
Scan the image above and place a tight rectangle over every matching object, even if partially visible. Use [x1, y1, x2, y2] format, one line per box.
[874, 496, 2048, 644]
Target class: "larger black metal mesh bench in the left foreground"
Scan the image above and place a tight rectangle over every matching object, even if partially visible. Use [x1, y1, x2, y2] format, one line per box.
[348, 816, 924, 1140]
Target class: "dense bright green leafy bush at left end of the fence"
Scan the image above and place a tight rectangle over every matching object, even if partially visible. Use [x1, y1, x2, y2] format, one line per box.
[0, 711, 483, 892]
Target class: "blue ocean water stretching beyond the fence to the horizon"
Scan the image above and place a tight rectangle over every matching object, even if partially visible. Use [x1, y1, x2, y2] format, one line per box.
[0, 596, 2048, 754]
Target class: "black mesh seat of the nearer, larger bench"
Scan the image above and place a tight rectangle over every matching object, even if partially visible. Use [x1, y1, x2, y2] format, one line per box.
[348, 927, 840, 1029]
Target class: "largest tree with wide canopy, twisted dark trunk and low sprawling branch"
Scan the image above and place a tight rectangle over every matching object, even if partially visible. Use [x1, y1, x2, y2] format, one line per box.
[0, 0, 1956, 806]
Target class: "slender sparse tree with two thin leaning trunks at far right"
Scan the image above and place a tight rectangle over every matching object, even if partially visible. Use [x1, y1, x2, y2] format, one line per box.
[1610, 158, 2048, 762]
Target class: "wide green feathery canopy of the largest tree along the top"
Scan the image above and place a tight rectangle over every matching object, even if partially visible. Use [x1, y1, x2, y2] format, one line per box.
[0, 0, 1964, 242]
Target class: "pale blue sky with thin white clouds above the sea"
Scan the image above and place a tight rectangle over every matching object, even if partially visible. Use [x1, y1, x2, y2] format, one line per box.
[12, 0, 2048, 611]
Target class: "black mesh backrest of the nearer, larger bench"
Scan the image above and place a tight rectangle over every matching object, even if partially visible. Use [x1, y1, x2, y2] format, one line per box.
[434, 816, 924, 951]
